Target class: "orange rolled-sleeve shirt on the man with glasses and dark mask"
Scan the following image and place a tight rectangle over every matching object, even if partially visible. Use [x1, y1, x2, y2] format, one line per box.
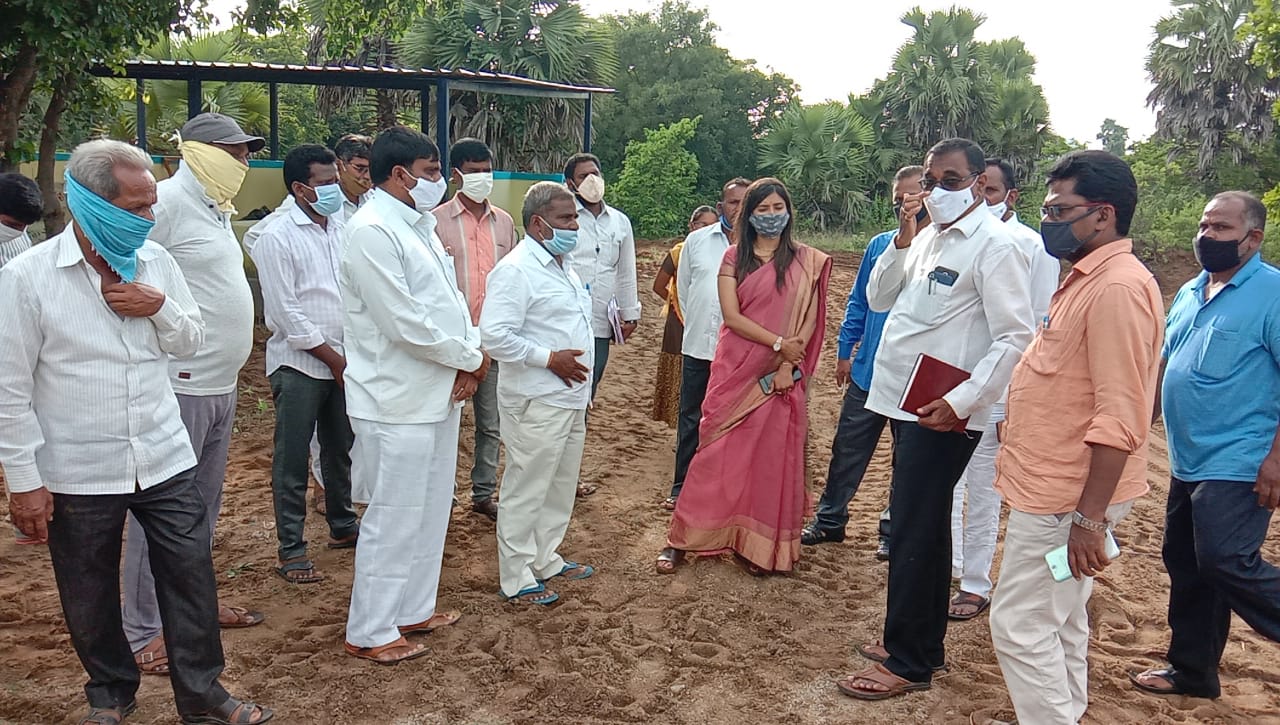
[996, 240, 1165, 514]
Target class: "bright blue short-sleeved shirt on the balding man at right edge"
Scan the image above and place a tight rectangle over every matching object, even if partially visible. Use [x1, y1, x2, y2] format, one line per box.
[1164, 255, 1280, 482]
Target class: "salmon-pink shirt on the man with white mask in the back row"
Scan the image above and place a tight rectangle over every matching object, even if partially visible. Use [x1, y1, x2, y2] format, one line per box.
[431, 196, 520, 324]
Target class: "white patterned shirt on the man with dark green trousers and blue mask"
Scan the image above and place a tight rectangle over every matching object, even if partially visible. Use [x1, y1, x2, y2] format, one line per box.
[252, 204, 343, 380]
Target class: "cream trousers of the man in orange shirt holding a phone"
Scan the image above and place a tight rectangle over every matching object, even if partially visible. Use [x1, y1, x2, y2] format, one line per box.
[991, 501, 1133, 725]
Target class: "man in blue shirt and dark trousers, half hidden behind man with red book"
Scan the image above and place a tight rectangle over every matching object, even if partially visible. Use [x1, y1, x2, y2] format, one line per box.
[800, 167, 929, 553]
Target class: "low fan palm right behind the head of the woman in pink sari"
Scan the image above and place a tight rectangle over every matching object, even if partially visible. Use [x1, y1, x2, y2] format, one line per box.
[759, 102, 876, 229]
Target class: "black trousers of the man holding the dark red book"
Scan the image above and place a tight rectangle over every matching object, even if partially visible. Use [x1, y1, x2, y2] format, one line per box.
[884, 421, 982, 683]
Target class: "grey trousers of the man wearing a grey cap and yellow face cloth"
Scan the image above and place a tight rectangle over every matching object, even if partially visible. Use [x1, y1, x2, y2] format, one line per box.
[123, 391, 236, 652]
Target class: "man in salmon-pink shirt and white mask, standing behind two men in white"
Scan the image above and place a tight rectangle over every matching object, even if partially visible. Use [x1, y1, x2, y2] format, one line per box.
[431, 138, 520, 521]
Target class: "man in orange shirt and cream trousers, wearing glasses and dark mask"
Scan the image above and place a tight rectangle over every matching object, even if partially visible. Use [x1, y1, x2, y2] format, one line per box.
[991, 151, 1164, 725]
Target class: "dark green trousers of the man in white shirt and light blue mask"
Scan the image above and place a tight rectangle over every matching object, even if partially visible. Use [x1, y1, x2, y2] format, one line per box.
[270, 368, 357, 561]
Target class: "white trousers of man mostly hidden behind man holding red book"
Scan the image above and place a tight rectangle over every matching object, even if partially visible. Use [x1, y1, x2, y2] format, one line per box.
[951, 402, 1005, 597]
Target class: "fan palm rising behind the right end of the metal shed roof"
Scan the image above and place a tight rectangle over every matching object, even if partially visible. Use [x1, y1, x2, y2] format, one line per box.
[396, 0, 619, 172]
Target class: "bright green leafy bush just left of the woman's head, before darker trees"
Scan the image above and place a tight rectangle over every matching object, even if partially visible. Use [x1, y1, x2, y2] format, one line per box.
[609, 117, 701, 240]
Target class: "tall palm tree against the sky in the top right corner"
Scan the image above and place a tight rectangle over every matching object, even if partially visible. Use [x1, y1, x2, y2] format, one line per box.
[1147, 0, 1280, 178]
